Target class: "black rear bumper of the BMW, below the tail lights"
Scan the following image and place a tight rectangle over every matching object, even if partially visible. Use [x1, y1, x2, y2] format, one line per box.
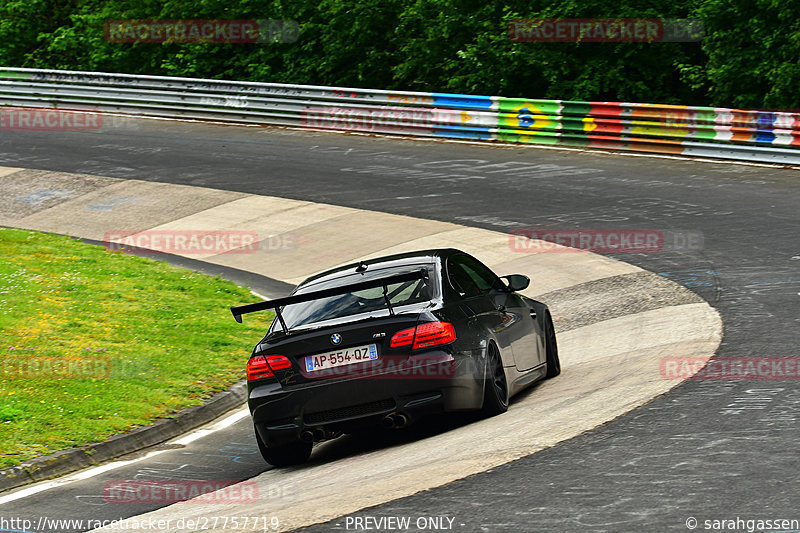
[248, 355, 483, 446]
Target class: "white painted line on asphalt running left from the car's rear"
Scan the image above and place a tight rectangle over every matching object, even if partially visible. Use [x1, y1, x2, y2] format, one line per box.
[0, 406, 250, 505]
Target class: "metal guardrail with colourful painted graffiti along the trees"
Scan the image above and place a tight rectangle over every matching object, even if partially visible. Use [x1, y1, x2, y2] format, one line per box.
[0, 68, 800, 165]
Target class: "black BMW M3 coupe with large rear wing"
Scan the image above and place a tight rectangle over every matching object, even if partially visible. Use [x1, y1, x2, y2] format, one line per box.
[231, 249, 561, 466]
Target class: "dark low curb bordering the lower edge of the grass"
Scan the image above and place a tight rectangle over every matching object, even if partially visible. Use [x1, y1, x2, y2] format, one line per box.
[0, 380, 247, 492]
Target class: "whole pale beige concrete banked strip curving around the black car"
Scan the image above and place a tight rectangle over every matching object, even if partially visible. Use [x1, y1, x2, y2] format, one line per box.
[0, 169, 722, 530]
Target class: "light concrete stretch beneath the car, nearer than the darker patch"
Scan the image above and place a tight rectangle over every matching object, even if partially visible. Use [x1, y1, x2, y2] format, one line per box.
[100, 303, 721, 531]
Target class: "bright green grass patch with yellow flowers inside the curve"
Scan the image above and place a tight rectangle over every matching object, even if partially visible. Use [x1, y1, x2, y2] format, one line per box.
[0, 228, 273, 466]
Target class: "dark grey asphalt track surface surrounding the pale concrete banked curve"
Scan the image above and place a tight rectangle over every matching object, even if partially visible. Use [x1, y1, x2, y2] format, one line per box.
[0, 119, 800, 532]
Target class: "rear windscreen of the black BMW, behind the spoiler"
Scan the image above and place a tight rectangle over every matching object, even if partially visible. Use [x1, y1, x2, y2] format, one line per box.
[281, 265, 435, 329]
